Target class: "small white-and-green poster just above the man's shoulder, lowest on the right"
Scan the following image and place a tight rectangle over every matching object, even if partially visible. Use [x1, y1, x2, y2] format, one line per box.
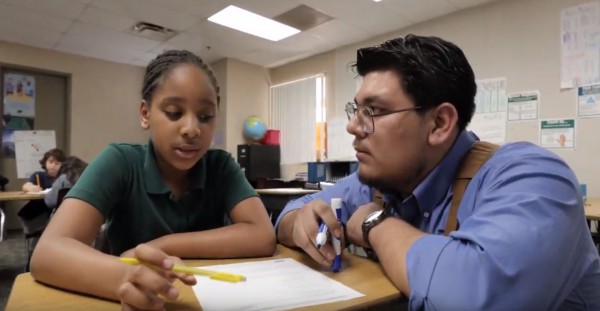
[540, 119, 575, 149]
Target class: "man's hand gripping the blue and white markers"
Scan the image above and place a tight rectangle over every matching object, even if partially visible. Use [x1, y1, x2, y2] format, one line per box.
[286, 200, 344, 266]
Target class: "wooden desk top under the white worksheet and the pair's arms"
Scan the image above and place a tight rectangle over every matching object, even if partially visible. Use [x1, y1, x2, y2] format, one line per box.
[6, 245, 400, 311]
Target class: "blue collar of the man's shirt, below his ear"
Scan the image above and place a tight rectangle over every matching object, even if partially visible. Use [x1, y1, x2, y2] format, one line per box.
[413, 130, 476, 212]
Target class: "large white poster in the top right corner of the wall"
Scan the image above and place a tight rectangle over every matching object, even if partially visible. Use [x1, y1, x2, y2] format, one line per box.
[560, 1, 600, 88]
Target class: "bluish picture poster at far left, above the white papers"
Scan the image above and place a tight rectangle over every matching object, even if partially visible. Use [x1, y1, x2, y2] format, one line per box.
[2, 73, 35, 158]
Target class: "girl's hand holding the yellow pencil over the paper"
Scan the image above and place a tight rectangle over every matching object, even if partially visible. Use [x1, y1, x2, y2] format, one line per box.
[117, 244, 196, 311]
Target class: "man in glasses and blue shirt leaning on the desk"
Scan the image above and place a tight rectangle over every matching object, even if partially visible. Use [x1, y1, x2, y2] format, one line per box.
[276, 35, 600, 310]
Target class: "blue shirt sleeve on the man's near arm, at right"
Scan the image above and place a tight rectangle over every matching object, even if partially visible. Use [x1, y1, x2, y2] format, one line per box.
[406, 147, 591, 311]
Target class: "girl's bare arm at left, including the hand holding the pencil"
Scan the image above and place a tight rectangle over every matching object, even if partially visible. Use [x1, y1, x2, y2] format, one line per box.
[31, 199, 196, 309]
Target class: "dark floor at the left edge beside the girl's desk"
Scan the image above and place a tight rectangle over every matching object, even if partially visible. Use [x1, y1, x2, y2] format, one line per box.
[0, 230, 26, 310]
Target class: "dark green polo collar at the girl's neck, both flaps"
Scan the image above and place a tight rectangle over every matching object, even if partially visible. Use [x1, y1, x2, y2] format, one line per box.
[144, 140, 206, 194]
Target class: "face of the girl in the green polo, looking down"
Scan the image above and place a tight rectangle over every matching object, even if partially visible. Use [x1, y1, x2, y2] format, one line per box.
[140, 64, 217, 172]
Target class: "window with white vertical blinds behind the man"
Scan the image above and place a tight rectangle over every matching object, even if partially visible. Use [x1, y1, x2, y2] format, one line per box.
[269, 75, 327, 164]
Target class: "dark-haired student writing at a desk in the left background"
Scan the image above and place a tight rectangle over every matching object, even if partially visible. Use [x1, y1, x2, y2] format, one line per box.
[22, 148, 66, 192]
